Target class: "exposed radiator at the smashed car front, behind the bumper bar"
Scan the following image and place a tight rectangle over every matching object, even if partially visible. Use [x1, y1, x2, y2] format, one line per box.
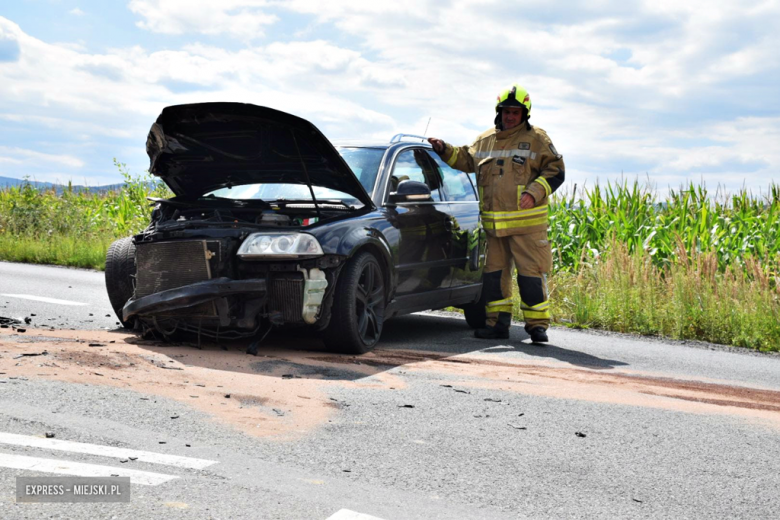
[135, 240, 218, 316]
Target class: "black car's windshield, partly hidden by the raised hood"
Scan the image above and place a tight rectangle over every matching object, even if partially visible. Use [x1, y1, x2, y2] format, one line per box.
[203, 147, 385, 206]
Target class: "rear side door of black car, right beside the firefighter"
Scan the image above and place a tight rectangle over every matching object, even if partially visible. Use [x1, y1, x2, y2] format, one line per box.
[429, 148, 486, 299]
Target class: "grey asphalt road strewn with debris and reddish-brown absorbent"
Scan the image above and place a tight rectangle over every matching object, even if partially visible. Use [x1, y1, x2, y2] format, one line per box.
[0, 263, 780, 520]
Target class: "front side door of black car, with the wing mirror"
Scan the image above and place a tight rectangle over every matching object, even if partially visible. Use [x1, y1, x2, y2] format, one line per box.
[386, 147, 452, 310]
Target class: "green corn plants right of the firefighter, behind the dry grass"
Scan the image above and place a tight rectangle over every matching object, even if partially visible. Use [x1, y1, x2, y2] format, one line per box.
[550, 182, 780, 273]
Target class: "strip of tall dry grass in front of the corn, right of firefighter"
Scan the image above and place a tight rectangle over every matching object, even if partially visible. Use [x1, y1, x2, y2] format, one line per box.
[551, 241, 780, 350]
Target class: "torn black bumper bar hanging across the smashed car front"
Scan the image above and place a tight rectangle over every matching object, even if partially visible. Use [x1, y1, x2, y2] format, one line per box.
[122, 278, 266, 320]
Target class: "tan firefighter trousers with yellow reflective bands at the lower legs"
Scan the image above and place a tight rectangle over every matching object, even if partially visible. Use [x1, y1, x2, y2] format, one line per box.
[483, 231, 552, 330]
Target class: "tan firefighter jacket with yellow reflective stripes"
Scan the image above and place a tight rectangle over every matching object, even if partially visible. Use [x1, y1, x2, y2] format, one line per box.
[441, 121, 565, 237]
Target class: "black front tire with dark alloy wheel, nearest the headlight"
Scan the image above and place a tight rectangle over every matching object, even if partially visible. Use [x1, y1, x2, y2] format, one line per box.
[323, 252, 385, 354]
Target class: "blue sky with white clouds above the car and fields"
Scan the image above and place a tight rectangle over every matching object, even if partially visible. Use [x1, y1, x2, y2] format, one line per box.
[0, 0, 780, 194]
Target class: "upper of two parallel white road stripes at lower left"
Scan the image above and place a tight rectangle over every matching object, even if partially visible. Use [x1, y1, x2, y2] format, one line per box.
[0, 432, 217, 469]
